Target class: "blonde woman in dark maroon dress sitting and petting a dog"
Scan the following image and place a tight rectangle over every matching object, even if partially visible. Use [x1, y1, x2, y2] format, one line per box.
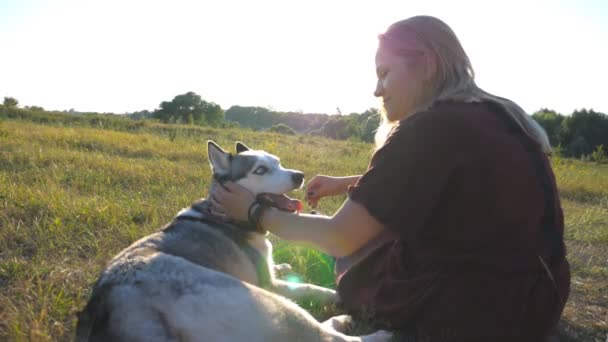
[213, 16, 570, 341]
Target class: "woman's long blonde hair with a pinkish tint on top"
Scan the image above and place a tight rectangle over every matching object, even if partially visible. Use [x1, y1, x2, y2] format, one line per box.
[375, 16, 551, 153]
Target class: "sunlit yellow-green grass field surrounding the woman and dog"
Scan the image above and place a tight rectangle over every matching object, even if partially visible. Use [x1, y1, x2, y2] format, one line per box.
[0, 118, 608, 342]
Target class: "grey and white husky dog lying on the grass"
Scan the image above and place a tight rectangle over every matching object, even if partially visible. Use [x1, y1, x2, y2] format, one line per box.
[76, 141, 391, 342]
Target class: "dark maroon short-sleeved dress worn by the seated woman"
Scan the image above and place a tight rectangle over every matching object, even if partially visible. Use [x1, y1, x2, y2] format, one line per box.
[337, 101, 570, 341]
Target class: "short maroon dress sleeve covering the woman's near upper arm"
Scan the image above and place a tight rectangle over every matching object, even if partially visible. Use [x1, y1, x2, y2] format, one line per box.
[348, 113, 462, 238]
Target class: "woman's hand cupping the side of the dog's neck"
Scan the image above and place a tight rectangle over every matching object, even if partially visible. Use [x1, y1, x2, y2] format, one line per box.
[209, 182, 255, 221]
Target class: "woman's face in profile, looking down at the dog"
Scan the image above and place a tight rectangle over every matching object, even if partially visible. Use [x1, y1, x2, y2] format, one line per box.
[374, 49, 427, 122]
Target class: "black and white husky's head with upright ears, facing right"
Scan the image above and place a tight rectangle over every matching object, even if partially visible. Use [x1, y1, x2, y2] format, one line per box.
[207, 140, 304, 195]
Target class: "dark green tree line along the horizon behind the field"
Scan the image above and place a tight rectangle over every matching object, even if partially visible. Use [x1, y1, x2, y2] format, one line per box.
[2, 92, 608, 158]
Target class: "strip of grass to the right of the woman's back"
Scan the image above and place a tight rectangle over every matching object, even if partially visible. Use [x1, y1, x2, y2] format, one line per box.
[552, 158, 608, 342]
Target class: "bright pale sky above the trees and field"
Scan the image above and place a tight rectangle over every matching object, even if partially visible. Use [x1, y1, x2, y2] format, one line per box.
[0, 0, 608, 114]
